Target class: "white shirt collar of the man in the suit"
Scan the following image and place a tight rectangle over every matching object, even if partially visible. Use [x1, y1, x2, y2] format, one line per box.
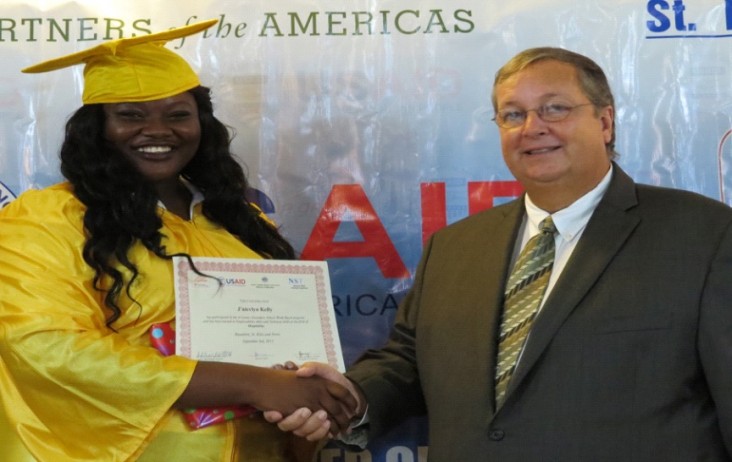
[524, 164, 613, 241]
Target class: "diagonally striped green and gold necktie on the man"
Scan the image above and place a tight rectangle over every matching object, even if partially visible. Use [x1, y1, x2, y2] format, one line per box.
[495, 215, 557, 409]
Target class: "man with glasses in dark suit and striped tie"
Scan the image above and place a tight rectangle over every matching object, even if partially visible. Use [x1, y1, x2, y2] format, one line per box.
[269, 48, 732, 462]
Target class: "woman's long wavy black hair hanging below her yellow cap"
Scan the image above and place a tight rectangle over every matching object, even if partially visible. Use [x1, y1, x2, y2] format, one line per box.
[60, 86, 295, 326]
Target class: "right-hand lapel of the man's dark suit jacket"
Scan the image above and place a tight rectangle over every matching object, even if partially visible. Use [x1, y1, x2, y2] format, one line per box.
[506, 165, 640, 408]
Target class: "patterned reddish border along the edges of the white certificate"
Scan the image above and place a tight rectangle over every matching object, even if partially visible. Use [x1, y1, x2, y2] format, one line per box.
[175, 257, 343, 370]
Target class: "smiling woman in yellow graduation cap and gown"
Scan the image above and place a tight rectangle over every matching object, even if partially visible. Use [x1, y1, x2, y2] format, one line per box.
[0, 20, 353, 462]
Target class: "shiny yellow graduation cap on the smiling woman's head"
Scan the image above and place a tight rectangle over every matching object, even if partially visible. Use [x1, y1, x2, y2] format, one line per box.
[22, 19, 218, 104]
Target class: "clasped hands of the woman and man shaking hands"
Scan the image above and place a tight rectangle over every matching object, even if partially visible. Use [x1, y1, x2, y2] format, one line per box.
[260, 362, 366, 441]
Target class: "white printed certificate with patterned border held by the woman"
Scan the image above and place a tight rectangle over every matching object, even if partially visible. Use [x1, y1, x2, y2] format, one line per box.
[173, 257, 345, 371]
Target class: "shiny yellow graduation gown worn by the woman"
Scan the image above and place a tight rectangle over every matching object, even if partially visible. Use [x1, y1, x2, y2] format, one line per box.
[0, 183, 306, 462]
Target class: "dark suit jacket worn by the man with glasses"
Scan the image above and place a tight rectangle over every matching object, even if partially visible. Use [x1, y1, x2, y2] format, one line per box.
[348, 165, 732, 462]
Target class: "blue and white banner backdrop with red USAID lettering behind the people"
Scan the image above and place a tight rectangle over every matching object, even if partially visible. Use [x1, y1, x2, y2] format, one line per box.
[0, 0, 732, 462]
